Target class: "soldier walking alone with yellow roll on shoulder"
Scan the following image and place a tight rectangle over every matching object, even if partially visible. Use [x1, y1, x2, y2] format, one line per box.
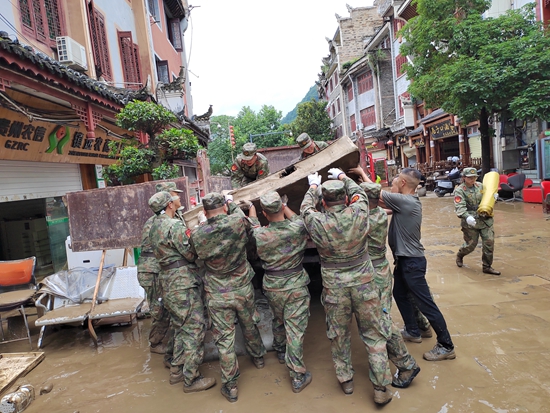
[455, 168, 500, 275]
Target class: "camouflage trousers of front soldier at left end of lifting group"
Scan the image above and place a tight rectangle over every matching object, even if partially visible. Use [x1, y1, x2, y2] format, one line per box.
[164, 288, 206, 385]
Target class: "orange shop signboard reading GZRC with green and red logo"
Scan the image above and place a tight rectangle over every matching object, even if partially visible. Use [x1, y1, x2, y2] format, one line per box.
[0, 108, 120, 165]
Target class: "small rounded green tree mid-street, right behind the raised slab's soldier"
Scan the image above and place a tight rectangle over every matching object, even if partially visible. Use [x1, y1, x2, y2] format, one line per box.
[290, 98, 332, 141]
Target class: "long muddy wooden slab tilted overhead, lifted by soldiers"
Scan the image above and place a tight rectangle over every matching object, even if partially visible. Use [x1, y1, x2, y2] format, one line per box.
[183, 136, 359, 228]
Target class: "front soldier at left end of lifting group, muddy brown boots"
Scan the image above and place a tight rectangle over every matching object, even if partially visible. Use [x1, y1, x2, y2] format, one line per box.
[149, 192, 216, 393]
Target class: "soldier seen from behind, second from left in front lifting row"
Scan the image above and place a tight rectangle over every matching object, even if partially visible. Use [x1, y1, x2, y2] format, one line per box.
[191, 192, 266, 402]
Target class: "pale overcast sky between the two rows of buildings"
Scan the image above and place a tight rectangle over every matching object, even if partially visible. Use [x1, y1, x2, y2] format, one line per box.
[185, 0, 372, 116]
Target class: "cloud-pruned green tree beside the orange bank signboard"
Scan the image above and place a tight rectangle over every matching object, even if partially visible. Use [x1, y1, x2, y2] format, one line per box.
[103, 100, 200, 185]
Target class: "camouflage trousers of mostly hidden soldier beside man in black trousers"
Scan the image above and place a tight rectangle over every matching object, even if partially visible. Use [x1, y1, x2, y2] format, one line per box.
[374, 260, 418, 371]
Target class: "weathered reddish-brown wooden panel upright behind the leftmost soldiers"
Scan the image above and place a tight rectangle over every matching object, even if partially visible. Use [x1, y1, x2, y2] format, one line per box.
[66, 177, 189, 252]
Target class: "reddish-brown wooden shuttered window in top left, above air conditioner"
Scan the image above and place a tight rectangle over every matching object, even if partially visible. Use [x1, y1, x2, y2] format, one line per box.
[19, 0, 65, 47]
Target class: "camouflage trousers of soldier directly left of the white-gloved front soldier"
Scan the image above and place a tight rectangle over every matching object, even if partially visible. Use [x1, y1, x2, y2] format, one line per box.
[265, 287, 310, 379]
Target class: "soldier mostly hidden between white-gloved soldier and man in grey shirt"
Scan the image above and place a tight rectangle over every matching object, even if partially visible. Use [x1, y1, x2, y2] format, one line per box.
[360, 182, 422, 389]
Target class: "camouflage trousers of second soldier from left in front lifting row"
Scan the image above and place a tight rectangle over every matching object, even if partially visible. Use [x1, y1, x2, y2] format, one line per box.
[206, 284, 266, 386]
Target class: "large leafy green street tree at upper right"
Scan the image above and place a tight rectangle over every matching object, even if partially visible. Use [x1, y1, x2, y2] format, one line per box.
[400, 0, 550, 172]
